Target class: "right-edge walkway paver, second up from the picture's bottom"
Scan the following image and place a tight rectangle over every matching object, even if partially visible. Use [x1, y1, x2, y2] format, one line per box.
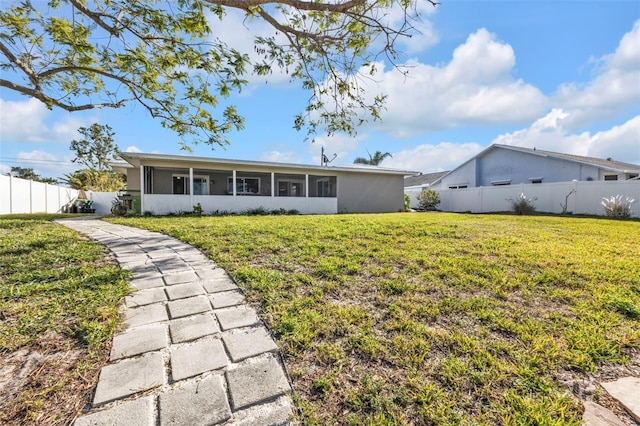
[227, 357, 291, 410]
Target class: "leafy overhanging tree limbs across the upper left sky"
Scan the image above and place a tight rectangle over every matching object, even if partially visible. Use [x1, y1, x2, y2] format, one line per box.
[0, 0, 437, 145]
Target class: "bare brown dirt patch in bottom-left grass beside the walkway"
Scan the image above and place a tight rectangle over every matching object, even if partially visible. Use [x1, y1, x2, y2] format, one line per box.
[0, 332, 100, 426]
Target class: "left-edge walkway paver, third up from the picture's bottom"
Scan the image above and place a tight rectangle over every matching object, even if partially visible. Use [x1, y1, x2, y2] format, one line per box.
[111, 323, 167, 360]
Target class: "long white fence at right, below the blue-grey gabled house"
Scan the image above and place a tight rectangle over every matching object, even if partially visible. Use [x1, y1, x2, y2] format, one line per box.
[405, 180, 640, 218]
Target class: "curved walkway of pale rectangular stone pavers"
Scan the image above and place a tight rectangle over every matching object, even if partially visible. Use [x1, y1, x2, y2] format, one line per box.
[58, 217, 293, 426]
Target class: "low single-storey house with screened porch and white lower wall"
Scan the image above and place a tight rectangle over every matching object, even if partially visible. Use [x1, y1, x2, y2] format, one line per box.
[112, 152, 416, 214]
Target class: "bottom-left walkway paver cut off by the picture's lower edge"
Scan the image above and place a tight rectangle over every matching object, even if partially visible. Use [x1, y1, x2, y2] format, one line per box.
[74, 396, 156, 426]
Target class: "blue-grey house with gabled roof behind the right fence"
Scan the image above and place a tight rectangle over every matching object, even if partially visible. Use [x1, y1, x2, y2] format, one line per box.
[429, 144, 640, 190]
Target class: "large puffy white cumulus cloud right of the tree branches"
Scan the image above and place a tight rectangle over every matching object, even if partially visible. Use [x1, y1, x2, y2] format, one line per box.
[364, 29, 547, 137]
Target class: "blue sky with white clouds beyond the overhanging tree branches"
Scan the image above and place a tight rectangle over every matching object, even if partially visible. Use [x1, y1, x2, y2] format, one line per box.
[0, 0, 640, 177]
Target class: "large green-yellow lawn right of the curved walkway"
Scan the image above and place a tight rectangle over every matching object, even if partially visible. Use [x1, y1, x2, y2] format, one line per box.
[110, 213, 640, 425]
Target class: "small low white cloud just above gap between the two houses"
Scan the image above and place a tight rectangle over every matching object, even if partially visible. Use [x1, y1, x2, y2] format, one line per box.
[384, 142, 484, 173]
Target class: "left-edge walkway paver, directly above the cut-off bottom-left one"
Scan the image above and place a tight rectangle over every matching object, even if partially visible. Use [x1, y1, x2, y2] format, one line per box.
[93, 352, 164, 405]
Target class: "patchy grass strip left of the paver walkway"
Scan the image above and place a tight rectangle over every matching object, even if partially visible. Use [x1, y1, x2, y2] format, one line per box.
[0, 215, 129, 425]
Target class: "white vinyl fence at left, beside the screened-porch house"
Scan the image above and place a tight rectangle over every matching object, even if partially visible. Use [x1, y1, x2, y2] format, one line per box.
[0, 175, 117, 214]
